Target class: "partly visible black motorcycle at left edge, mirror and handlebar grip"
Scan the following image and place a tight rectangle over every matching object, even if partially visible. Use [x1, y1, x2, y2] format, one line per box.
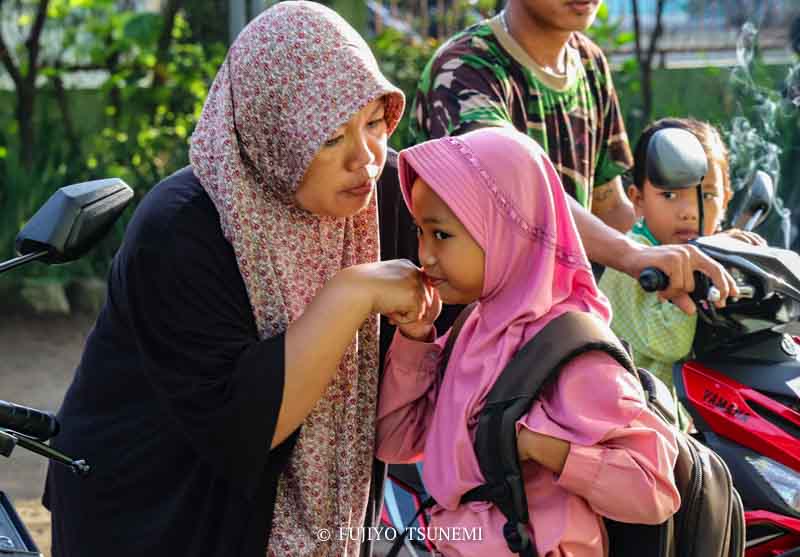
[0, 178, 133, 557]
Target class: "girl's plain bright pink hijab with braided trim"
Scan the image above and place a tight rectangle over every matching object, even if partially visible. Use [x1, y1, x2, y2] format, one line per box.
[399, 128, 610, 510]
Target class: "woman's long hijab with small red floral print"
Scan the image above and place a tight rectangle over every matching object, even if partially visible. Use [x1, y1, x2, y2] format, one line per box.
[190, 2, 404, 556]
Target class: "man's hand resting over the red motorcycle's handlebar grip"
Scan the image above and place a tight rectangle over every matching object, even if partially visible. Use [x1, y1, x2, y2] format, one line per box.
[618, 244, 739, 315]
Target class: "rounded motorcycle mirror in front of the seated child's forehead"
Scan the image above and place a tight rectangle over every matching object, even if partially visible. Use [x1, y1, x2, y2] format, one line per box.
[647, 128, 708, 190]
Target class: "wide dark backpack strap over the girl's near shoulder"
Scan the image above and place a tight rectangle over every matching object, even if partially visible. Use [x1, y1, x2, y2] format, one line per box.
[461, 312, 636, 557]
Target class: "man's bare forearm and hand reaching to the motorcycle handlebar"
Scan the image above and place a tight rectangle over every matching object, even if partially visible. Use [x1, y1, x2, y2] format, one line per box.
[567, 197, 738, 314]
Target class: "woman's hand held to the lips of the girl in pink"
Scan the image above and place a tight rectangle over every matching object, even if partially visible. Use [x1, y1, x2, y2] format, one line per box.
[343, 259, 434, 324]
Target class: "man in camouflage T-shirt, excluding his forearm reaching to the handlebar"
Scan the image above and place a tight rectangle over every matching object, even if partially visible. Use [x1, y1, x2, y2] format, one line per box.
[410, 0, 634, 232]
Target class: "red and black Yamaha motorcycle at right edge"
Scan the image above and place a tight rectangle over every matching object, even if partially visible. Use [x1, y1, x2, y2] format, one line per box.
[673, 179, 800, 557]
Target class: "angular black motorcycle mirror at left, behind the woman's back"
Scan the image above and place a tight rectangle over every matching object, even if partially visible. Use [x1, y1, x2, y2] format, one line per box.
[12, 178, 133, 264]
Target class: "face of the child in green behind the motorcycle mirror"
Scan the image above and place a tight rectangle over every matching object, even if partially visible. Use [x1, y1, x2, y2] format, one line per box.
[628, 161, 730, 244]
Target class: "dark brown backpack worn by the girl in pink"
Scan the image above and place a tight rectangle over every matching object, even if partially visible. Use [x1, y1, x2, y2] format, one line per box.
[390, 304, 744, 557]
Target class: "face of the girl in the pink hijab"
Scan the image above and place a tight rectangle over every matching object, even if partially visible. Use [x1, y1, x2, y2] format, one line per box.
[411, 178, 485, 304]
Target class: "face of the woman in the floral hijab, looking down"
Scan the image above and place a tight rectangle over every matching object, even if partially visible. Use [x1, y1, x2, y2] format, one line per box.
[295, 99, 387, 218]
